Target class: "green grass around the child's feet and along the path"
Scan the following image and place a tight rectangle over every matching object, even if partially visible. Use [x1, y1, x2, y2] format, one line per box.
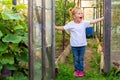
[55, 38, 120, 80]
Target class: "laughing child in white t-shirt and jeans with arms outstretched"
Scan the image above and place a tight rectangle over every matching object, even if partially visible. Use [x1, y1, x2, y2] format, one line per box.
[55, 7, 104, 76]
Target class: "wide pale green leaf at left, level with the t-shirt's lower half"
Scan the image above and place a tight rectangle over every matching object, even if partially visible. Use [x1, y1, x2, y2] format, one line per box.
[2, 34, 22, 43]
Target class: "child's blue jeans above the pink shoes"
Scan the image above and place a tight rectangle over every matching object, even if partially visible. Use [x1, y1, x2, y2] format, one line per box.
[71, 46, 86, 71]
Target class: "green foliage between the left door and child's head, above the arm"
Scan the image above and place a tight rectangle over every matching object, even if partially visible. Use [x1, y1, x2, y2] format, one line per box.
[55, 0, 74, 26]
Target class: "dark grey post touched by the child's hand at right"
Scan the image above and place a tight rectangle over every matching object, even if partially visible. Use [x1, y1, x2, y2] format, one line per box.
[104, 0, 111, 73]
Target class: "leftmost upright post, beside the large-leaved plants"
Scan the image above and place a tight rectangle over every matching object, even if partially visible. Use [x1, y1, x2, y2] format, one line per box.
[28, 0, 34, 80]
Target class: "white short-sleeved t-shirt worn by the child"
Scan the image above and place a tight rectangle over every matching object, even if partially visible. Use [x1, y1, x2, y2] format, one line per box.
[64, 20, 90, 47]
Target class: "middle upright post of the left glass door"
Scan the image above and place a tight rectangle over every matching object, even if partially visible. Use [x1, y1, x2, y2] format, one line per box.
[42, 0, 46, 80]
